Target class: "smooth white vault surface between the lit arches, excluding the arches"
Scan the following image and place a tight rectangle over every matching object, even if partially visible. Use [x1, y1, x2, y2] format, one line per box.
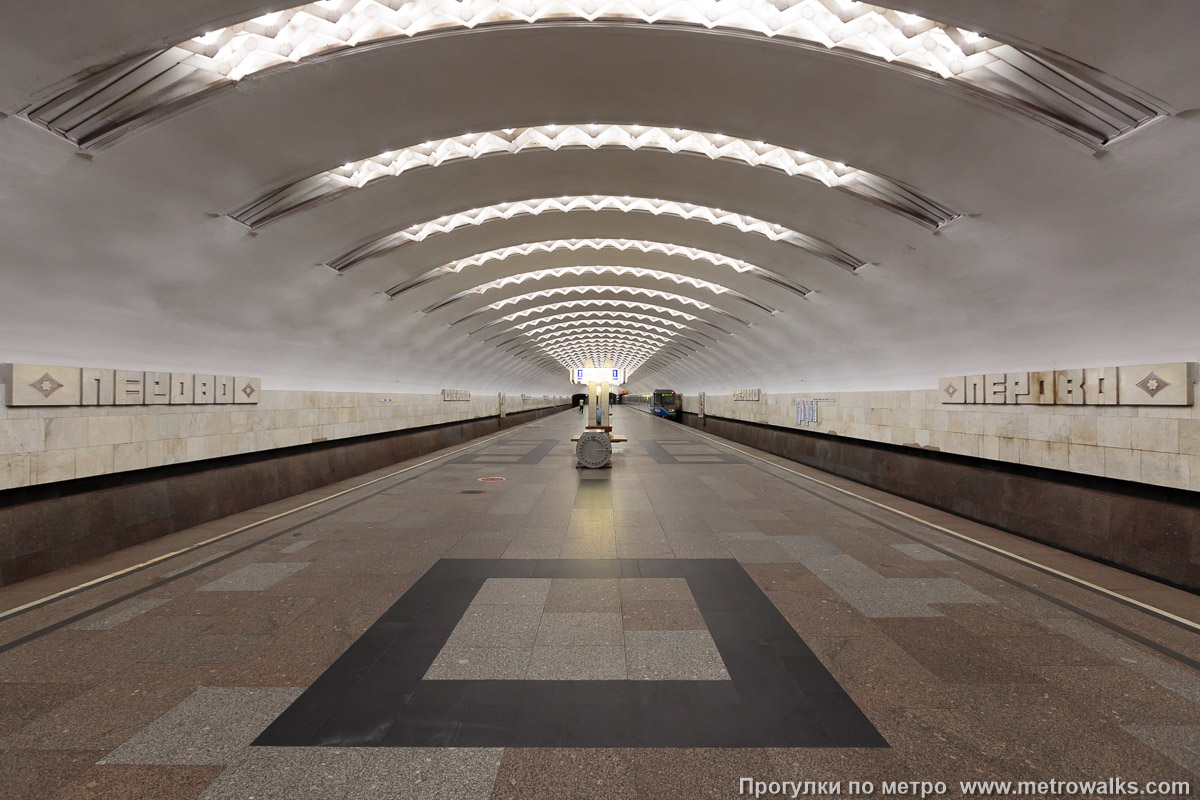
[0, 0, 1200, 393]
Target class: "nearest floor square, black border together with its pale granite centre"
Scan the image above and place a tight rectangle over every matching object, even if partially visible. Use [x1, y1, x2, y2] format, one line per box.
[254, 559, 887, 747]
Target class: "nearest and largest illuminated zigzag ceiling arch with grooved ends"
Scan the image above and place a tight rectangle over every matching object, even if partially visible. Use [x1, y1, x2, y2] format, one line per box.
[14, 0, 1169, 148]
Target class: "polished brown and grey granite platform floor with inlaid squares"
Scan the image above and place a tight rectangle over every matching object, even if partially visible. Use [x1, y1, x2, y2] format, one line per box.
[0, 408, 1200, 800]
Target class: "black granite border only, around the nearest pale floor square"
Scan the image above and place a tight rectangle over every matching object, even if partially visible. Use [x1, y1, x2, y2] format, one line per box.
[254, 559, 887, 747]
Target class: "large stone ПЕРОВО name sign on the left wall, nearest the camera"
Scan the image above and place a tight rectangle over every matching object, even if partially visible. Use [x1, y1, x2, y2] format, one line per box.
[0, 363, 263, 405]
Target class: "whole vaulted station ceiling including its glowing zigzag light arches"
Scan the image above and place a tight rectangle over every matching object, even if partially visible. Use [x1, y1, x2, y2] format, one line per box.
[0, 0, 1200, 392]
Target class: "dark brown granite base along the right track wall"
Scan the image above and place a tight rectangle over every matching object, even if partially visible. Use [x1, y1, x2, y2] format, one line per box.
[683, 413, 1200, 591]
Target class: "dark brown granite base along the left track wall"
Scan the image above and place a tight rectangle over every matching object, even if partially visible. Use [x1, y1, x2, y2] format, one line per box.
[0, 405, 568, 585]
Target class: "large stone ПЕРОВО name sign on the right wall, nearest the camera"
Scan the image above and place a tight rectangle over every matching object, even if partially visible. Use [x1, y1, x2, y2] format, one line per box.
[937, 361, 1196, 405]
